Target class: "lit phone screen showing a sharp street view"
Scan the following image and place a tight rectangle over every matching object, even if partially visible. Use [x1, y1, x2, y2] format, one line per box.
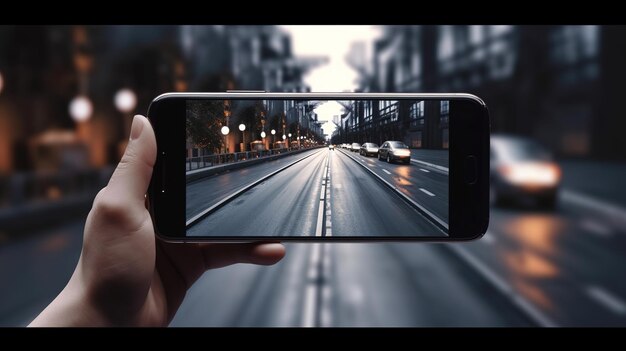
[185, 99, 450, 237]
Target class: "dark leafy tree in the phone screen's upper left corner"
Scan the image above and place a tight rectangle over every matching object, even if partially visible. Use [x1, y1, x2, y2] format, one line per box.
[186, 100, 226, 150]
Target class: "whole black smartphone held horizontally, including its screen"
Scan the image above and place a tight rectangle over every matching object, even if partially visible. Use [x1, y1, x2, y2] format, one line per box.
[148, 92, 490, 242]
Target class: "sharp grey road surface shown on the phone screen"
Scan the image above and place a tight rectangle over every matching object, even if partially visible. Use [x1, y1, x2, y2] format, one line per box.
[187, 148, 448, 236]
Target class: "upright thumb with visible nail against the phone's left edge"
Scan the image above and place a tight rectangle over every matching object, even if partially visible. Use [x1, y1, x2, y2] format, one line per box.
[107, 115, 157, 206]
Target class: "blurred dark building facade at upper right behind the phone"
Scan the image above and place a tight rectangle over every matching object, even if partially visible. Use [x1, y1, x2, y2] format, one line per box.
[337, 25, 626, 161]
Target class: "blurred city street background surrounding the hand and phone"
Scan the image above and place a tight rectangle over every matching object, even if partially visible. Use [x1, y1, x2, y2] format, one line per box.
[0, 25, 626, 326]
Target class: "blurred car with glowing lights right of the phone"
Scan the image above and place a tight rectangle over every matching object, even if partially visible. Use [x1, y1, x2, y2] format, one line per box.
[489, 135, 561, 208]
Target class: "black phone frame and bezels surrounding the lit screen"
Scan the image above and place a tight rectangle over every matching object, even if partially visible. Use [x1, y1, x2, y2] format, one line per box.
[147, 91, 490, 243]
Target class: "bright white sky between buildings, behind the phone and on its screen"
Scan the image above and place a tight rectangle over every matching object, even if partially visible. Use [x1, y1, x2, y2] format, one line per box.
[281, 25, 379, 137]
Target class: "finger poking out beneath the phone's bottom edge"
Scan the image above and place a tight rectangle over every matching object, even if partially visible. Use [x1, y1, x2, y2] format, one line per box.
[201, 243, 285, 270]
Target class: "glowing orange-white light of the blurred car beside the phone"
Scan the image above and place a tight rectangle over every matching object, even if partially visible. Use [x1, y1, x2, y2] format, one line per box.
[498, 162, 561, 186]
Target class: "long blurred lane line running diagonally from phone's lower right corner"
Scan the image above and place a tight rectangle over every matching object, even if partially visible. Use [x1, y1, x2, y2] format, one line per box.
[446, 245, 558, 327]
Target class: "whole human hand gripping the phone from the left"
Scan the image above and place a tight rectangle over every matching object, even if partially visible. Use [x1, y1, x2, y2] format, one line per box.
[30, 116, 285, 326]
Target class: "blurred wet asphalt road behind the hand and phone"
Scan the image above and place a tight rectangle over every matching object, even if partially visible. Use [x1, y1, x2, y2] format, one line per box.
[0, 151, 626, 326]
